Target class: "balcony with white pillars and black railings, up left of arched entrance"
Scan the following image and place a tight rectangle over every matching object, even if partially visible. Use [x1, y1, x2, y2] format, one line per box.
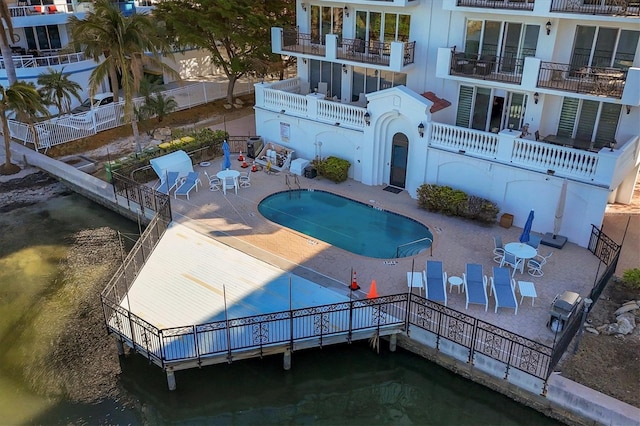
[271, 28, 415, 71]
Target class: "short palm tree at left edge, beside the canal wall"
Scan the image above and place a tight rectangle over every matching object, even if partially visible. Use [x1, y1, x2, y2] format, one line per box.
[0, 81, 49, 175]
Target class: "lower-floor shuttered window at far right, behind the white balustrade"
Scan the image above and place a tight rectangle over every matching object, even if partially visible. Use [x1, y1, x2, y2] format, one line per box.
[557, 97, 622, 149]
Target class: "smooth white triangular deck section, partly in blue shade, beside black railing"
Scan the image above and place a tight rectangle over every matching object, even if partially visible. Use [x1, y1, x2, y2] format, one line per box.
[121, 222, 349, 329]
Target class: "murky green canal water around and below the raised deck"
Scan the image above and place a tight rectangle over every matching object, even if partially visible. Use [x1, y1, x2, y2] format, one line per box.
[0, 191, 557, 425]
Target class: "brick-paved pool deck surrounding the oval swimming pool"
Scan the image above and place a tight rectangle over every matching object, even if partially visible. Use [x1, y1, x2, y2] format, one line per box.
[171, 155, 602, 345]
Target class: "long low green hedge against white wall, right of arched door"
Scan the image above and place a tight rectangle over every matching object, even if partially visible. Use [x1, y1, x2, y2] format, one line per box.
[417, 184, 499, 223]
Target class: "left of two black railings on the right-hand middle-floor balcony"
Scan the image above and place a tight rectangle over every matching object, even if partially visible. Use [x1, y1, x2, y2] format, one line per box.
[451, 52, 524, 84]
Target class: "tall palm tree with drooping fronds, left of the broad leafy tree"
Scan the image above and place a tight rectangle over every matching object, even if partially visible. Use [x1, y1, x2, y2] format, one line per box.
[69, 0, 179, 151]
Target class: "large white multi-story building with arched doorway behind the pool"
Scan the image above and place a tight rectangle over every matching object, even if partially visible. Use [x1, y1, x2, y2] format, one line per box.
[255, 0, 640, 246]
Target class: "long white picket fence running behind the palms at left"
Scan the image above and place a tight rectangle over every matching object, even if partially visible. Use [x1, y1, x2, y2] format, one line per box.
[9, 81, 254, 152]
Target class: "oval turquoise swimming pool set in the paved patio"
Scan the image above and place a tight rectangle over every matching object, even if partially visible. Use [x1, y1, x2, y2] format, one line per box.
[258, 189, 433, 259]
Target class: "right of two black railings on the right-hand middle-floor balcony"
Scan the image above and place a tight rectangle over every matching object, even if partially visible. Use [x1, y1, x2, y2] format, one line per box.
[537, 62, 627, 99]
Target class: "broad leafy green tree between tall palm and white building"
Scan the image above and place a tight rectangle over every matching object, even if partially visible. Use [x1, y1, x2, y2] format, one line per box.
[154, 0, 295, 104]
